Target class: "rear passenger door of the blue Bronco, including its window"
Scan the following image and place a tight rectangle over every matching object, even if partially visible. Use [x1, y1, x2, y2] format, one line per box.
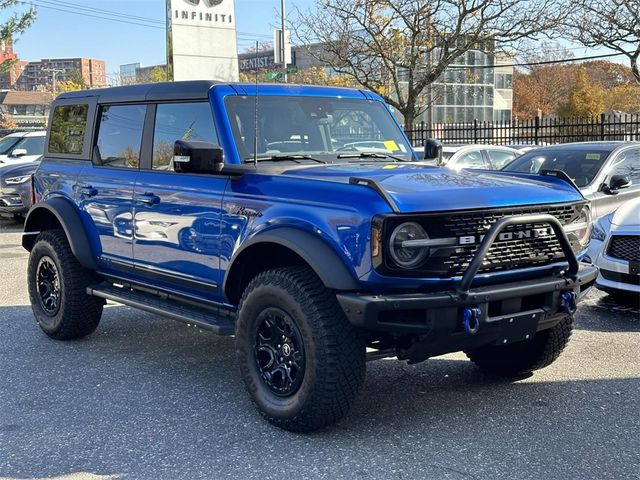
[75, 104, 147, 270]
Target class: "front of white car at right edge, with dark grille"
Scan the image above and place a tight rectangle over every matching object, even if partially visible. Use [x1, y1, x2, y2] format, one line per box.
[587, 198, 640, 299]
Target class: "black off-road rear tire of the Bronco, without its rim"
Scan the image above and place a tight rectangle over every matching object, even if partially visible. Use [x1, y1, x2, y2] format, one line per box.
[27, 230, 104, 340]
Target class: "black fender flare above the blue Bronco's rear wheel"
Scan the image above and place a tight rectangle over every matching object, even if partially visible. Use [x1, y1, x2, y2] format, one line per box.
[22, 197, 97, 270]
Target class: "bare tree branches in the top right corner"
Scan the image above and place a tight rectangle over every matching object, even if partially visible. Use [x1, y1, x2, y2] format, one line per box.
[563, 0, 640, 83]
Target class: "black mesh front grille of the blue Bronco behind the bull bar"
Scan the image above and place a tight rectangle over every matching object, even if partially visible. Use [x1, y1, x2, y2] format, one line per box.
[387, 203, 584, 278]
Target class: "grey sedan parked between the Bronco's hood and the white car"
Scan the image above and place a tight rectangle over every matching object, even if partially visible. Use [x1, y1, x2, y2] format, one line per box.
[502, 142, 640, 219]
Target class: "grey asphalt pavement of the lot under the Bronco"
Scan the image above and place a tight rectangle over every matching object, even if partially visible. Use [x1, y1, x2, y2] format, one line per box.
[0, 220, 640, 480]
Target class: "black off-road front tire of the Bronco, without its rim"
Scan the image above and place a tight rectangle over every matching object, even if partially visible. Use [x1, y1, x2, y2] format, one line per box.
[236, 266, 365, 432]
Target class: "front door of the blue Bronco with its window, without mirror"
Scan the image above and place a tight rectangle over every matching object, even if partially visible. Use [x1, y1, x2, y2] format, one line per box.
[134, 102, 227, 299]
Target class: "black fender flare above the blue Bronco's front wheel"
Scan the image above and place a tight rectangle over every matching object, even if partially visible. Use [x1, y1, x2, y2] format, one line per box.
[222, 227, 361, 298]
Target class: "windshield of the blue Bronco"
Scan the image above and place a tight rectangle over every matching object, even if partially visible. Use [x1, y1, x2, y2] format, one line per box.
[226, 96, 413, 161]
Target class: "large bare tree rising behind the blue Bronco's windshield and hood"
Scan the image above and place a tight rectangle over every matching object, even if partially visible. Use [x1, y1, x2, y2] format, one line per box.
[292, 0, 564, 130]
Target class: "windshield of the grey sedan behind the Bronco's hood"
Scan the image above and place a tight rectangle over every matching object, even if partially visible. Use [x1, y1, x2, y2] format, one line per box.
[502, 147, 611, 187]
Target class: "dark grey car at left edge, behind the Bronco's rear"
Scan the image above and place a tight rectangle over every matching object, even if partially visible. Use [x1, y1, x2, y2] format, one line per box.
[0, 159, 40, 217]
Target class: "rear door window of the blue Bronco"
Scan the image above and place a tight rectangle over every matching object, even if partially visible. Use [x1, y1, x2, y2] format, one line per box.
[96, 105, 147, 168]
